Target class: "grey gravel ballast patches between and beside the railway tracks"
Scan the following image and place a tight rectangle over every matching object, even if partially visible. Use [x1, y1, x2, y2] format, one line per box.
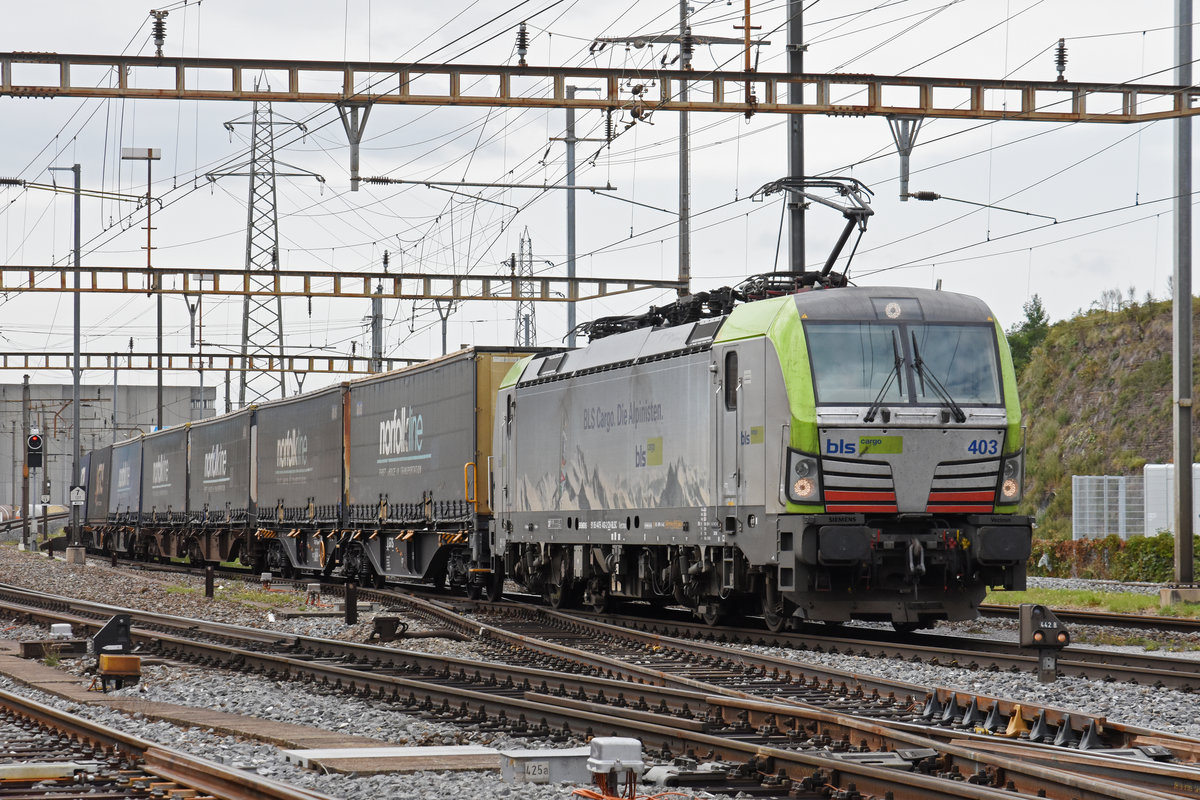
[0, 547, 1200, 800]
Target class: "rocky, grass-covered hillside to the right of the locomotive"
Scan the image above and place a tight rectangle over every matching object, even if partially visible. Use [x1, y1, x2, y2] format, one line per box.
[1019, 301, 1200, 539]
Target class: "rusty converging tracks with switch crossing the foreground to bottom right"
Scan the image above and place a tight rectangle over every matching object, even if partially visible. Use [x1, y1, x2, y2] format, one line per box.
[4, 589, 1200, 800]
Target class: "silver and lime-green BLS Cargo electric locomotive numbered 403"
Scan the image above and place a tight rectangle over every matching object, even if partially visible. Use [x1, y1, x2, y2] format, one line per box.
[487, 283, 1032, 628]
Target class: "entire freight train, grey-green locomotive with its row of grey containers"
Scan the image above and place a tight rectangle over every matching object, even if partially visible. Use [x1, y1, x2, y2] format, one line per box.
[77, 285, 1031, 628]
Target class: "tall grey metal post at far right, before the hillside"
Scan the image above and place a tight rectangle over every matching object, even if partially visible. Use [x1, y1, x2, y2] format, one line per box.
[1172, 0, 1195, 585]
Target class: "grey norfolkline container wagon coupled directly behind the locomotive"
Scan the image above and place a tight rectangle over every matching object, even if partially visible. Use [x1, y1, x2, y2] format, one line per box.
[347, 348, 528, 577]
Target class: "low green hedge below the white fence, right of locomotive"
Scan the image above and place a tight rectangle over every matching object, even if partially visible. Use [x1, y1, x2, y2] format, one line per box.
[1028, 533, 1200, 583]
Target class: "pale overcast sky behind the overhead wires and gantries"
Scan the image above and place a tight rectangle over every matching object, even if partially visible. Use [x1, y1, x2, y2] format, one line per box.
[0, 0, 1190, 400]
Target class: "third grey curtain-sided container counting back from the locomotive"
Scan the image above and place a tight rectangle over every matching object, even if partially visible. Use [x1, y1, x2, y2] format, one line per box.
[187, 409, 254, 525]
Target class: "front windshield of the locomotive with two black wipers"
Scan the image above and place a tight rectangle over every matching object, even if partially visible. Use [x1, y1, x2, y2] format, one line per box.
[804, 320, 1002, 405]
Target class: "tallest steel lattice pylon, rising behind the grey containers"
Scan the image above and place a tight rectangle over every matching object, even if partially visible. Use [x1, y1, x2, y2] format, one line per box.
[208, 95, 325, 408]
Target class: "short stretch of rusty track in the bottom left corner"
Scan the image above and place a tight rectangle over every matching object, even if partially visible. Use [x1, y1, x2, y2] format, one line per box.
[0, 692, 329, 800]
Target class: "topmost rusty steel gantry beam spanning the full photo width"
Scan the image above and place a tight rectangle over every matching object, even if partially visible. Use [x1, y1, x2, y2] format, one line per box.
[0, 53, 1198, 122]
